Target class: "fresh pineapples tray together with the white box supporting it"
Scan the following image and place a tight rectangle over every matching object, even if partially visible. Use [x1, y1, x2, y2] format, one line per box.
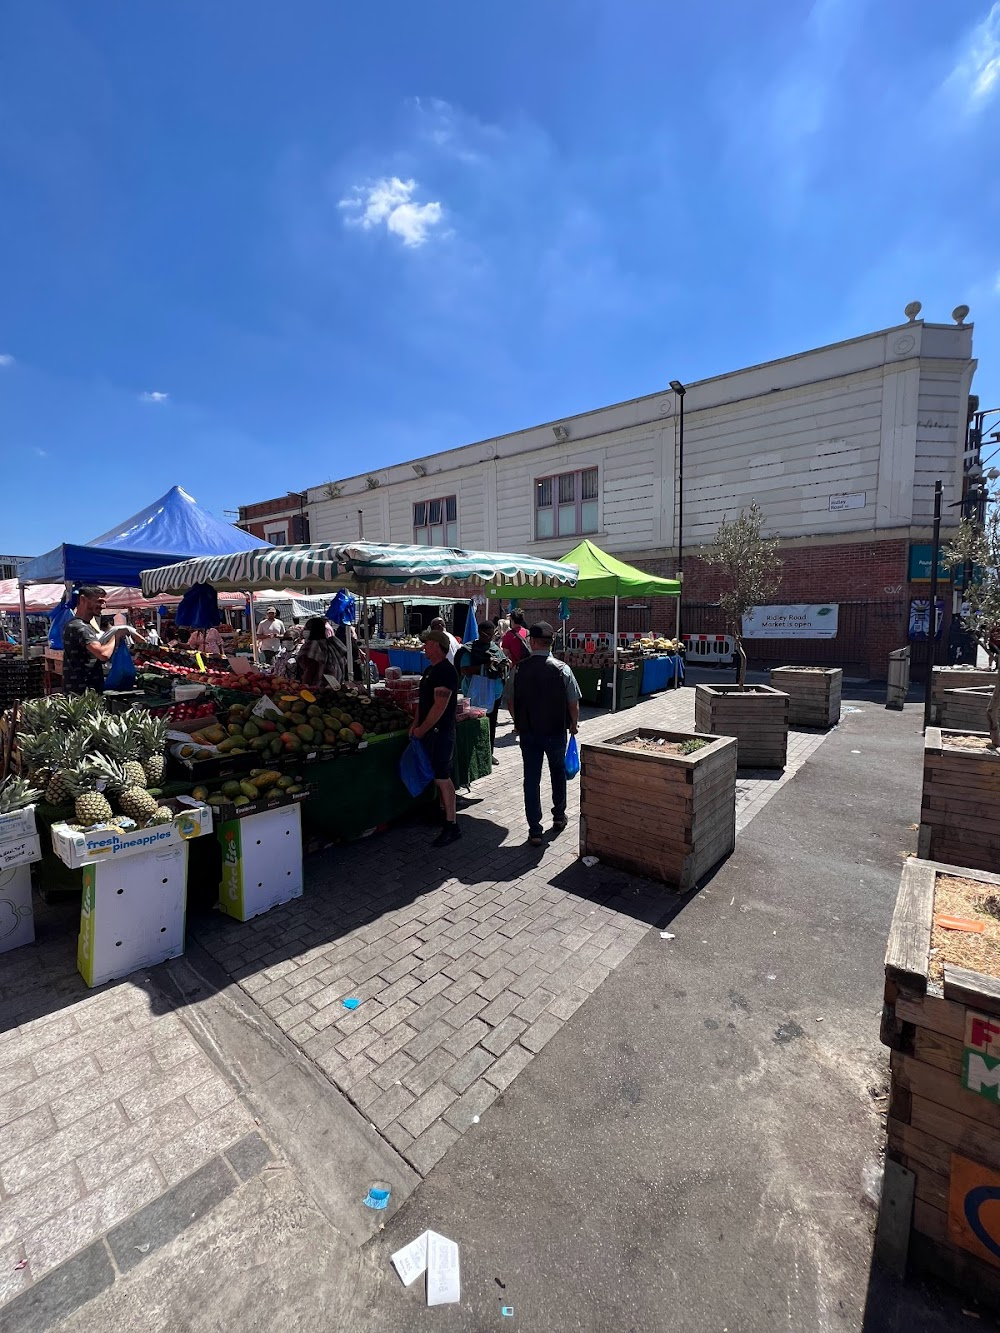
[52, 802, 212, 986]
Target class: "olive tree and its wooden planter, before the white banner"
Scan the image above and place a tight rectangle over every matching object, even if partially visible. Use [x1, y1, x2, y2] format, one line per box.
[695, 500, 788, 768]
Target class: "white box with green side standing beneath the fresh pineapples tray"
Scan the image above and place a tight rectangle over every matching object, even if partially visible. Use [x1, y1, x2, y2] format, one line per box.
[76, 829, 188, 986]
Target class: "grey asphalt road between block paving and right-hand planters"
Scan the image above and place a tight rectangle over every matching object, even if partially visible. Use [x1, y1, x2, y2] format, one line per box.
[356, 701, 991, 1333]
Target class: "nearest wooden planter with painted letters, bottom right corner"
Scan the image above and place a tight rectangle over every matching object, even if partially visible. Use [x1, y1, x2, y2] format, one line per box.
[876, 860, 1000, 1306]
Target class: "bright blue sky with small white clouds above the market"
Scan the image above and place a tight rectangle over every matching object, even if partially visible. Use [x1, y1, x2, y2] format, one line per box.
[0, 0, 1000, 555]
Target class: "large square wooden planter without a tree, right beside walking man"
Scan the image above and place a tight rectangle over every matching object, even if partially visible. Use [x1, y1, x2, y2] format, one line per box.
[580, 726, 736, 889]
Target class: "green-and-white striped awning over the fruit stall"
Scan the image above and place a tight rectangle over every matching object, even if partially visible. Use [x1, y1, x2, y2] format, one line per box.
[143, 541, 577, 596]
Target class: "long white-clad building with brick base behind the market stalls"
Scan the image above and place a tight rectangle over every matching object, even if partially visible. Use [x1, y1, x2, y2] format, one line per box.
[308, 320, 975, 668]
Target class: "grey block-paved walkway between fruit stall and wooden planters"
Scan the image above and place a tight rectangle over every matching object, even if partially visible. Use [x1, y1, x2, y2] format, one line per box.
[195, 689, 825, 1174]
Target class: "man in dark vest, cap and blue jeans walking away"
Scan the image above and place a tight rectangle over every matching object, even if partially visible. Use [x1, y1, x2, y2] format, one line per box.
[511, 620, 580, 846]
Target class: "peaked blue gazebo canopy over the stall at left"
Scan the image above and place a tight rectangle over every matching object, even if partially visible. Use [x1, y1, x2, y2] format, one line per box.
[20, 487, 269, 588]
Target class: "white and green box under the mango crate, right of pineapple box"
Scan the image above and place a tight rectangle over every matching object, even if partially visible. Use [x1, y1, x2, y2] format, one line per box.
[219, 802, 303, 921]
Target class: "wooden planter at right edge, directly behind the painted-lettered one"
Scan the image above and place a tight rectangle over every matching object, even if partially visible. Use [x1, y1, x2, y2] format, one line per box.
[917, 726, 1000, 870]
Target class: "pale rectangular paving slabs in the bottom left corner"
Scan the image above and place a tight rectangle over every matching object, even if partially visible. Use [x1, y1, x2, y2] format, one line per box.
[0, 949, 262, 1306]
